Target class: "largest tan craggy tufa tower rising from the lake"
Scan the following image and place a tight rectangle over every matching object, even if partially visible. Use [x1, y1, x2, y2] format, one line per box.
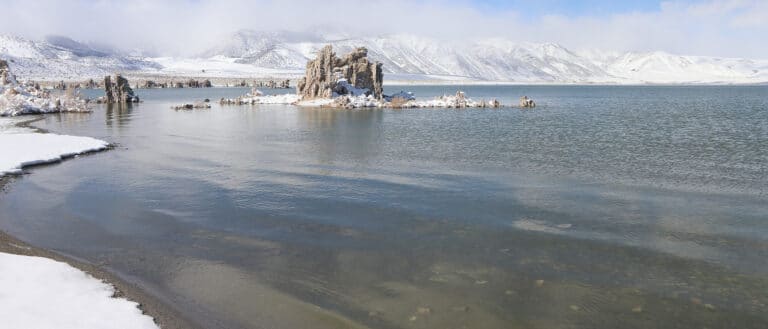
[296, 45, 384, 100]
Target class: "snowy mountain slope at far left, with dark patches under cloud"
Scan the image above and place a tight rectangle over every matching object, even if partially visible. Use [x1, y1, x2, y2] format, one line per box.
[0, 35, 161, 80]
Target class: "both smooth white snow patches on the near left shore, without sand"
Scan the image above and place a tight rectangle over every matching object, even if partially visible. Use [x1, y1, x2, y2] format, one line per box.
[0, 118, 158, 329]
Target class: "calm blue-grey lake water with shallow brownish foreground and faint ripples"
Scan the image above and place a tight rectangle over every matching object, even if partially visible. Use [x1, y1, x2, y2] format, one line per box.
[0, 86, 768, 329]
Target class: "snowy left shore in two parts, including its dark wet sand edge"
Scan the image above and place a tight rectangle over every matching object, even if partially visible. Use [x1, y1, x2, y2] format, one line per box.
[0, 118, 195, 329]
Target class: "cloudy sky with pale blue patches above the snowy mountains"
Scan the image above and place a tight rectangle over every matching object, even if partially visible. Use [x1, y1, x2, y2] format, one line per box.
[0, 0, 768, 59]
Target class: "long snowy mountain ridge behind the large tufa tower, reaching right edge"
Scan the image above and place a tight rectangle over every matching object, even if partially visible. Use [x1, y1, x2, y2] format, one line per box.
[203, 31, 768, 83]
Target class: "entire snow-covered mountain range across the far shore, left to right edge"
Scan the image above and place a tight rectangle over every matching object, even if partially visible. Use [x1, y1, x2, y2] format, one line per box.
[0, 30, 768, 83]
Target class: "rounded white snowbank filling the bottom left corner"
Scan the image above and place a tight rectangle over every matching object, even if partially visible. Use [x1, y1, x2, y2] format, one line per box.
[0, 253, 158, 329]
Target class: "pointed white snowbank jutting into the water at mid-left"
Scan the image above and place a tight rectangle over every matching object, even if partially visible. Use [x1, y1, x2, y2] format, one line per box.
[0, 119, 109, 176]
